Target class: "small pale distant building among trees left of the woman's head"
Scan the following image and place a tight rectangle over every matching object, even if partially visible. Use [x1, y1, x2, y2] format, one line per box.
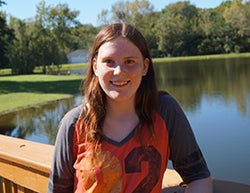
[67, 49, 89, 64]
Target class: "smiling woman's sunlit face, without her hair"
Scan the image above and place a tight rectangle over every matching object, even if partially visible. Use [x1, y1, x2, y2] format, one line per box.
[93, 37, 149, 102]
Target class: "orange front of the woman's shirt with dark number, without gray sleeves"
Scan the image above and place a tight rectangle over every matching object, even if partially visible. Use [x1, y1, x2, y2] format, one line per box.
[74, 113, 169, 193]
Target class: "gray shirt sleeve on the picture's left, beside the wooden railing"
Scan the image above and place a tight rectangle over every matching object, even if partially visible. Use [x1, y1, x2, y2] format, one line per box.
[48, 107, 80, 193]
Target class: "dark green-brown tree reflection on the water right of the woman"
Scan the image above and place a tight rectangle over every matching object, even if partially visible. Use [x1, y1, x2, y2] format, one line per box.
[155, 58, 250, 115]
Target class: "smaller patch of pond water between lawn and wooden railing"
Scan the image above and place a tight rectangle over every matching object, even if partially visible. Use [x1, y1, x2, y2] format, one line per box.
[0, 96, 82, 144]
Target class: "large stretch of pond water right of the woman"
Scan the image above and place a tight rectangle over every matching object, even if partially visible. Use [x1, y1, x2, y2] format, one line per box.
[156, 58, 250, 184]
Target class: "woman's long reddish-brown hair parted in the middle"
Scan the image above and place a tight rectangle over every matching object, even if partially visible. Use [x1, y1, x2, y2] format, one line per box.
[79, 23, 157, 145]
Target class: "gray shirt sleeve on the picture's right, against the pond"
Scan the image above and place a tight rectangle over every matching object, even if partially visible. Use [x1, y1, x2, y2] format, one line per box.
[159, 94, 210, 183]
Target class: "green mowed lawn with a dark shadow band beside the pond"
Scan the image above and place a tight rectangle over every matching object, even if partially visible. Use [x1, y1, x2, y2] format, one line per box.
[0, 74, 83, 114]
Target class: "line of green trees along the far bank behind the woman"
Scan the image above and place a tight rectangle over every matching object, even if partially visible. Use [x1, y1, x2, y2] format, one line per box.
[0, 0, 250, 74]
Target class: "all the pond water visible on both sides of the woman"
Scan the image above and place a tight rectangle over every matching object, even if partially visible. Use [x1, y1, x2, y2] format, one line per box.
[0, 58, 250, 184]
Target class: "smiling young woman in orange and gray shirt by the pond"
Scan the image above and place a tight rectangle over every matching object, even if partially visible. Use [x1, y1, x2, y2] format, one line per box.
[48, 23, 212, 193]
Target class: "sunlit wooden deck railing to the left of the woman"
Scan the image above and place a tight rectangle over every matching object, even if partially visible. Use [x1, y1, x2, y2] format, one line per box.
[0, 135, 54, 193]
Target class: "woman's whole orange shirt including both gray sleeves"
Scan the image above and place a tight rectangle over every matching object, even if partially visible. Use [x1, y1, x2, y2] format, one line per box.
[48, 93, 210, 193]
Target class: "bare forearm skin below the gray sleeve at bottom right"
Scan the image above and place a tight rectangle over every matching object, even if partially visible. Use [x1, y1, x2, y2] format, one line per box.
[185, 177, 213, 193]
